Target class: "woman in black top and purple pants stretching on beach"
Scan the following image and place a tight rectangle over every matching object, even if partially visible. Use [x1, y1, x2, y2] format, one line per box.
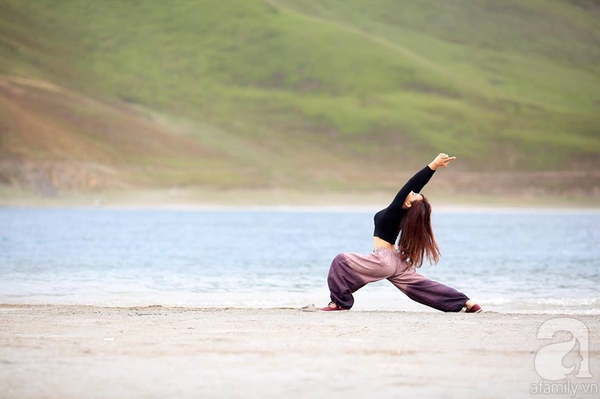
[321, 153, 481, 313]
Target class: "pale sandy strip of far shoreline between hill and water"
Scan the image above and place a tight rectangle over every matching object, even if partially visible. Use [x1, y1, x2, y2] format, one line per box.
[0, 186, 600, 212]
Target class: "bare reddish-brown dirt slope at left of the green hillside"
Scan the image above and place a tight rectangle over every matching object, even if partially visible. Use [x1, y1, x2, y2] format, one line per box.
[0, 75, 238, 194]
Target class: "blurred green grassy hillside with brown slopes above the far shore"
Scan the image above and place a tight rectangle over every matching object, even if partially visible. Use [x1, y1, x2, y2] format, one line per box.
[0, 0, 600, 195]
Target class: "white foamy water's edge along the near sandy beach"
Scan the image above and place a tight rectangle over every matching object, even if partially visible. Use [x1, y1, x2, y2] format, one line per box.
[0, 288, 600, 314]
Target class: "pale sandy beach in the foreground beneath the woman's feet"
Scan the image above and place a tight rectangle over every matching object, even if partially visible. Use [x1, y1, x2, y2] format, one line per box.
[0, 305, 600, 399]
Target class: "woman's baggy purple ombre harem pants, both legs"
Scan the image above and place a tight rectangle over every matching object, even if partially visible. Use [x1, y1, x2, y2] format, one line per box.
[327, 248, 469, 312]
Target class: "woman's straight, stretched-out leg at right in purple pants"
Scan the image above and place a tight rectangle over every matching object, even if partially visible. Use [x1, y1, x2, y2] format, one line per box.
[388, 267, 469, 312]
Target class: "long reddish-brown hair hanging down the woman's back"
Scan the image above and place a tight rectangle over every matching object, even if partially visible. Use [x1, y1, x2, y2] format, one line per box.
[398, 196, 440, 267]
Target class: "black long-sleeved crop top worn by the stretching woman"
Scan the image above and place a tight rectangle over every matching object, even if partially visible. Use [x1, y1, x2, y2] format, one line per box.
[373, 166, 435, 245]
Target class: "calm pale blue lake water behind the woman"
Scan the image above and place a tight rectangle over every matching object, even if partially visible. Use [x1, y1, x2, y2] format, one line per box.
[0, 208, 600, 313]
